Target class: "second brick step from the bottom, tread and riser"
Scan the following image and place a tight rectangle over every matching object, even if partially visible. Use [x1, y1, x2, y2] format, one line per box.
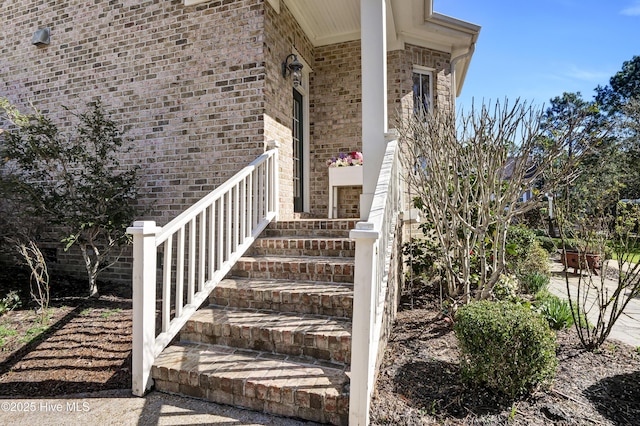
[180, 305, 351, 364]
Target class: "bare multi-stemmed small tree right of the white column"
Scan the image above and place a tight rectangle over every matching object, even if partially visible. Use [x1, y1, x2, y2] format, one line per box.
[399, 102, 603, 301]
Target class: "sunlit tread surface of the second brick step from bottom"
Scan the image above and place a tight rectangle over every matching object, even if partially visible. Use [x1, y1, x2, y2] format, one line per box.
[189, 305, 351, 336]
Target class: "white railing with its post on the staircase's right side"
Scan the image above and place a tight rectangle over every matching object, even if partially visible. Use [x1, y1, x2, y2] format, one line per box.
[349, 140, 402, 425]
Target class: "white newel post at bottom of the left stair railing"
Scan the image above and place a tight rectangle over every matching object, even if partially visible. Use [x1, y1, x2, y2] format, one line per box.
[127, 221, 159, 396]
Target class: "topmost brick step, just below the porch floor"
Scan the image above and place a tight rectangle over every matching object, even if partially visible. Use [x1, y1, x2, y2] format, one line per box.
[262, 219, 358, 238]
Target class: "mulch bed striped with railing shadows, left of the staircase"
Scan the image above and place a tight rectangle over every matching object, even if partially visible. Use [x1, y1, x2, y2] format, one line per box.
[0, 277, 132, 398]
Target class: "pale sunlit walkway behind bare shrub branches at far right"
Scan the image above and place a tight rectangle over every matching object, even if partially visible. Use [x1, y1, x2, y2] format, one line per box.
[549, 259, 640, 347]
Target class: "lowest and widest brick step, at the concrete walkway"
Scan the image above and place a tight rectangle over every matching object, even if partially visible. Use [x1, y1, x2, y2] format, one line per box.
[151, 343, 349, 425]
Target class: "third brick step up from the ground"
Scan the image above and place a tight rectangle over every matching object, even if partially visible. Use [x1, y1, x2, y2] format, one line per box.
[209, 278, 353, 318]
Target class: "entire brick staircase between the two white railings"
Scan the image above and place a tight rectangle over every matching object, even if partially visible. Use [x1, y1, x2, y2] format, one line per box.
[151, 219, 356, 425]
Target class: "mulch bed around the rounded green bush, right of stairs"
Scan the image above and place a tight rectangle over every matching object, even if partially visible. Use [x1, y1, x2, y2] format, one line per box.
[370, 286, 640, 425]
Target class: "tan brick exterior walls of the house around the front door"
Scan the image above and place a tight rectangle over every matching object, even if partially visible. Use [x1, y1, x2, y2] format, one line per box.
[0, 0, 458, 277]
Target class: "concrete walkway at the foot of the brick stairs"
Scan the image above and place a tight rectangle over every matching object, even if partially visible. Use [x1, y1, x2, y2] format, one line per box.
[0, 390, 316, 426]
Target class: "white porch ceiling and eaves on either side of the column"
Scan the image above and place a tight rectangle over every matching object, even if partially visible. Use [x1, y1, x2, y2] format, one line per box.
[280, 0, 480, 94]
